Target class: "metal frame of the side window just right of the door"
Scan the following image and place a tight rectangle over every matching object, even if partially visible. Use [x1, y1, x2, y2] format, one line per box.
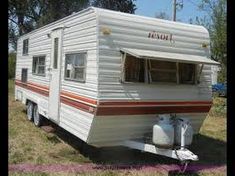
[64, 51, 88, 83]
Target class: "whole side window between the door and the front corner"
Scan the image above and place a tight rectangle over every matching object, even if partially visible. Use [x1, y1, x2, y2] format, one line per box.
[65, 53, 87, 82]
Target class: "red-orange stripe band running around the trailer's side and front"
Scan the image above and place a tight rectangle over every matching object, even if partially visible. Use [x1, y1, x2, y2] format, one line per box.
[15, 80, 212, 116]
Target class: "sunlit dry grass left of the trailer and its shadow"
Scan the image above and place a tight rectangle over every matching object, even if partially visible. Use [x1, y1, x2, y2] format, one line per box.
[8, 81, 90, 164]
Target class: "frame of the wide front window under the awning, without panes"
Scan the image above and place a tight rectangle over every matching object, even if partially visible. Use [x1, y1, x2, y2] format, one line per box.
[123, 53, 198, 86]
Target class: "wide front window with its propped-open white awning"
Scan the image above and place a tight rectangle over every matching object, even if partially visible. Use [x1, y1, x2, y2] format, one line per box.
[121, 48, 219, 84]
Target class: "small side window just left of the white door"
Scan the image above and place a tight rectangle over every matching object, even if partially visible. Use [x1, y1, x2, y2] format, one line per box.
[32, 56, 46, 75]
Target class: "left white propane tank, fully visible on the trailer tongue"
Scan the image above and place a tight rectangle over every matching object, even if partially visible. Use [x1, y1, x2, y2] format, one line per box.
[152, 114, 174, 148]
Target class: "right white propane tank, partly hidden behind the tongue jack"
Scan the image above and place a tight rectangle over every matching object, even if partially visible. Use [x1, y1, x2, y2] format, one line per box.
[175, 118, 193, 146]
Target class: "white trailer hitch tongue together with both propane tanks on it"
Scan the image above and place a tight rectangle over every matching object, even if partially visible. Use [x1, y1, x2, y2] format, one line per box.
[120, 114, 199, 172]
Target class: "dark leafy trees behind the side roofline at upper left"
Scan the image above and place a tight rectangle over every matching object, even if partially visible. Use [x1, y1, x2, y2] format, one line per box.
[8, 0, 89, 49]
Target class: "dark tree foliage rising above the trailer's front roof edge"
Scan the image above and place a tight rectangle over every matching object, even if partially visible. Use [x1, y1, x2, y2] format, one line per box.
[91, 0, 136, 14]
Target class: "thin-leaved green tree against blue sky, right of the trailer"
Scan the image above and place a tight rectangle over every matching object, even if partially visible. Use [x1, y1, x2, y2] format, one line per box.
[190, 0, 227, 82]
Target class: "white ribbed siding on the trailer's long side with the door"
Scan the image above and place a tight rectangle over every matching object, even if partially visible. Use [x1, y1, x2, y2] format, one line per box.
[15, 8, 98, 141]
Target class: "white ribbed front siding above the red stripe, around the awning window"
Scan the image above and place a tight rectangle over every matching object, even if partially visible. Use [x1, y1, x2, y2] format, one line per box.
[97, 9, 211, 101]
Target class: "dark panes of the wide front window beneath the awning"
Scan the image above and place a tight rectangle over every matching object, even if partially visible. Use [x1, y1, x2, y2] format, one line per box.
[124, 56, 196, 84]
